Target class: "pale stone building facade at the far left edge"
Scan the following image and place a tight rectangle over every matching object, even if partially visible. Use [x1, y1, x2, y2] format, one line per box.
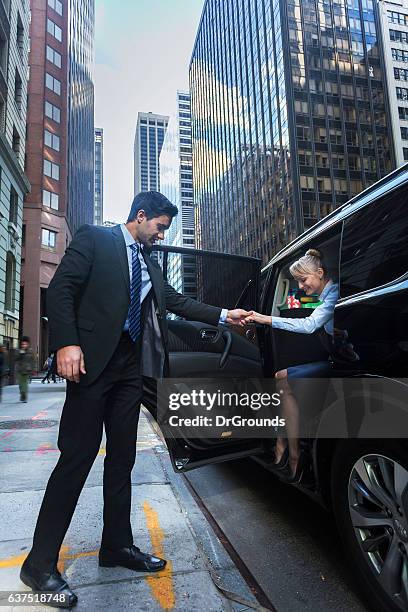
[0, 0, 30, 349]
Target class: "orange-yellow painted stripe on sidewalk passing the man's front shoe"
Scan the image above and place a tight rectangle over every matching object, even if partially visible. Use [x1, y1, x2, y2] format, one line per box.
[143, 501, 176, 610]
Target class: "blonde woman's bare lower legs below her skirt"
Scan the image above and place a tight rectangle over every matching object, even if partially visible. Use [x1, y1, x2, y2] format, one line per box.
[275, 370, 300, 474]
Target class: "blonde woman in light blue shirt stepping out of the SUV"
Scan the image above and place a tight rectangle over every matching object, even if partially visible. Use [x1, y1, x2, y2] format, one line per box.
[246, 249, 339, 483]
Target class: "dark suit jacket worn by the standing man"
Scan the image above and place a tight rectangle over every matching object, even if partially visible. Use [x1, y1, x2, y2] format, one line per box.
[47, 225, 221, 386]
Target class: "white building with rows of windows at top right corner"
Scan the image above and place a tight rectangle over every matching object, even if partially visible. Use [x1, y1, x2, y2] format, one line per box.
[378, 0, 408, 166]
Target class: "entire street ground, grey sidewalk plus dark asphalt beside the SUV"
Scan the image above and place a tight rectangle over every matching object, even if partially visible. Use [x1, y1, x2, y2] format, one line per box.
[0, 381, 372, 612]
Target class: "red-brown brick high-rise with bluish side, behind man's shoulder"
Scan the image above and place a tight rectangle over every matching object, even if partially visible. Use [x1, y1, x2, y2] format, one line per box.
[21, 0, 94, 366]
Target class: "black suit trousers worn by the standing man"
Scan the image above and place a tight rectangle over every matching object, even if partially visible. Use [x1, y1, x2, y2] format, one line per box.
[29, 334, 142, 571]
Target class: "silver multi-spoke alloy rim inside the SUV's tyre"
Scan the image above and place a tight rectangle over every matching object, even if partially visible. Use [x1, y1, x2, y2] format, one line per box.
[348, 454, 408, 610]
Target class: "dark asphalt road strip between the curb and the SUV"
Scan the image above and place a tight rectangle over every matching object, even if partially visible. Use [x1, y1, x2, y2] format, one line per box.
[187, 460, 369, 612]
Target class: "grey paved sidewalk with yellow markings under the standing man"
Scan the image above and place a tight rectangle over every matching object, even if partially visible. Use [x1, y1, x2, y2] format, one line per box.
[0, 381, 254, 612]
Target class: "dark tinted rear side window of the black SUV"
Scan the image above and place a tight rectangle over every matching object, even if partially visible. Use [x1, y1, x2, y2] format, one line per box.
[340, 185, 408, 297]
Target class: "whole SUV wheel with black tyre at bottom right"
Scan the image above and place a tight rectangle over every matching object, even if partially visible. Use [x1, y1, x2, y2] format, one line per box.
[331, 440, 408, 612]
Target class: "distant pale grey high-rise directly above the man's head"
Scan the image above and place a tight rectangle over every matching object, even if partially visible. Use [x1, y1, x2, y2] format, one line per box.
[133, 113, 169, 195]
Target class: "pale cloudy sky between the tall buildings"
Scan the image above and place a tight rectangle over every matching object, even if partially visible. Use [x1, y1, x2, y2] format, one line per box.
[94, 0, 204, 222]
